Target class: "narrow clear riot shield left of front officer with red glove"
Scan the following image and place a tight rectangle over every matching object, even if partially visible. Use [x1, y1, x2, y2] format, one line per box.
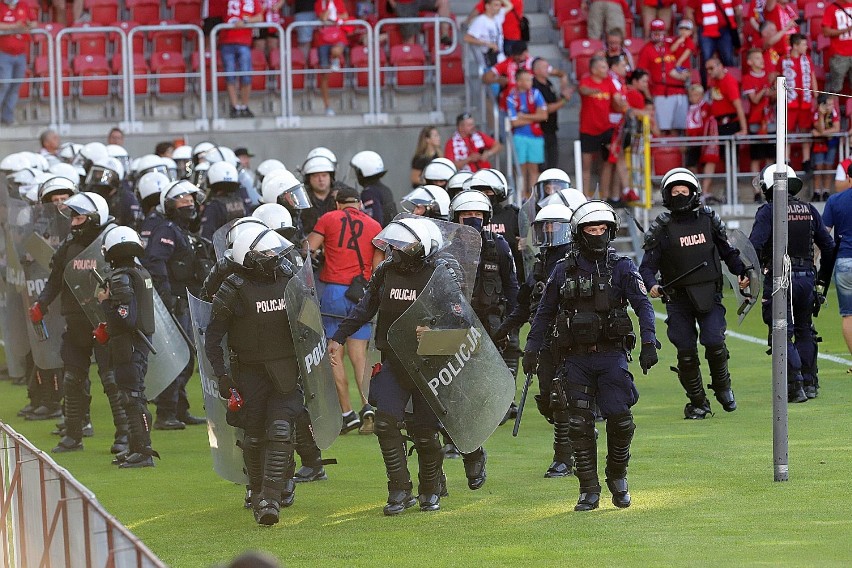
[189, 294, 248, 484]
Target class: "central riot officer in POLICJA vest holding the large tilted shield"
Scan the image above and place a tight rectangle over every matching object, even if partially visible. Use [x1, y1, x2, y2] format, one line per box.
[328, 219, 460, 515]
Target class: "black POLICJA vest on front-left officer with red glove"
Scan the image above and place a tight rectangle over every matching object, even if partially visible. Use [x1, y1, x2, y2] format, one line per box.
[228, 276, 299, 363]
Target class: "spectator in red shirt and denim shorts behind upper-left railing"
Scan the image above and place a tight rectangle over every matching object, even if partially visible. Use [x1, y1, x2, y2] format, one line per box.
[219, 0, 263, 118]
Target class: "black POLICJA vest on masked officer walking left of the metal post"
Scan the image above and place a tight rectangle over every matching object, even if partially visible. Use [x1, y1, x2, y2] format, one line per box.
[660, 213, 722, 288]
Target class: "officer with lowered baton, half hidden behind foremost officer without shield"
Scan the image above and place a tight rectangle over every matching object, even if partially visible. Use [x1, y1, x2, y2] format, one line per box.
[494, 203, 574, 478]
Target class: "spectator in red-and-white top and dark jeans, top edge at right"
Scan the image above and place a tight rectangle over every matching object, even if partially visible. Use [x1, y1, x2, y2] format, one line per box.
[684, 0, 743, 80]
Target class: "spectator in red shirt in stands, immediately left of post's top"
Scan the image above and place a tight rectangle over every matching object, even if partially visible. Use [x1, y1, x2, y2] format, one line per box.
[743, 48, 775, 203]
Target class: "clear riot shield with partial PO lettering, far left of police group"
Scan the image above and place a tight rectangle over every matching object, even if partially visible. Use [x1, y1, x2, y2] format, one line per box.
[9, 201, 71, 369]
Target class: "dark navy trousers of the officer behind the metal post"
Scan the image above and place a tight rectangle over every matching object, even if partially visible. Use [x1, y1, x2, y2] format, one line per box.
[761, 270, 817, 383]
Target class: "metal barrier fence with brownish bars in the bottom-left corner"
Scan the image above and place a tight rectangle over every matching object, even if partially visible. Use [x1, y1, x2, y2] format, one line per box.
[0, 422, 165, 568]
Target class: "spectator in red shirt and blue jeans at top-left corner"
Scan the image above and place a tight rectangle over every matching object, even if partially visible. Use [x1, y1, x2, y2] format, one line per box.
[0, 0, 32, 126]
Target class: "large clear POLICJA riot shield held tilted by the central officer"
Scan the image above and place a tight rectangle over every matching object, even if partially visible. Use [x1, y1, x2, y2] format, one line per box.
[388, 266, 515, 453]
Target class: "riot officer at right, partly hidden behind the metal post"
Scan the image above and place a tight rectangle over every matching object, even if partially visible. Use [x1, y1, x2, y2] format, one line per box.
[749, 164, 835, 402]
